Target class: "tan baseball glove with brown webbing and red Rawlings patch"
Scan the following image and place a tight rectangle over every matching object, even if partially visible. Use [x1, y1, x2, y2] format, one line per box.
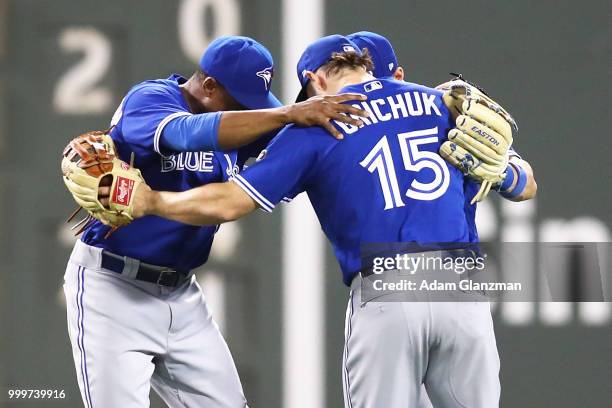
[62, 131, 144, 236]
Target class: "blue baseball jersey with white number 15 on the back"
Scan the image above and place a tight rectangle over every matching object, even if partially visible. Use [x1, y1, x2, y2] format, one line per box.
[232, 79, 474, 285]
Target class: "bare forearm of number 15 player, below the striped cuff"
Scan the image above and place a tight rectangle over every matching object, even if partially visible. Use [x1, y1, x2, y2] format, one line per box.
[134, 181, 257, 225]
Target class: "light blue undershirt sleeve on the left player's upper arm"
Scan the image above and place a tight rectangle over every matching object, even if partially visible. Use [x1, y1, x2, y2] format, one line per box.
[159, 112, 222, 154]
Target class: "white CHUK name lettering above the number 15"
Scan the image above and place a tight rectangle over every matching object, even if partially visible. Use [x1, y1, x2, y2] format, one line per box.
[334, 91, 442, 135]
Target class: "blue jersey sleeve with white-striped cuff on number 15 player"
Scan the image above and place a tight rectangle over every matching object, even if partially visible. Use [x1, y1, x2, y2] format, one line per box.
[232, 126, 326, 212]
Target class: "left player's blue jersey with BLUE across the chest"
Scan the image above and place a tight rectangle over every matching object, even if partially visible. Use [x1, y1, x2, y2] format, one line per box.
[81, 75, 239, 271]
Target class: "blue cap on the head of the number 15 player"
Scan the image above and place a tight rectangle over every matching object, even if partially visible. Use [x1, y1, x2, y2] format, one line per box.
[296, 34, 361, 102]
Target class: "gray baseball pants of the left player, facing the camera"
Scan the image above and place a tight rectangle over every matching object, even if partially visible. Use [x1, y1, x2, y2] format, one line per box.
[64, 241, 247, 408]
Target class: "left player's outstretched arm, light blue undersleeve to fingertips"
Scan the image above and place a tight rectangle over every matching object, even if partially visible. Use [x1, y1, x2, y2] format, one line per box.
[159, 94, 367, 152]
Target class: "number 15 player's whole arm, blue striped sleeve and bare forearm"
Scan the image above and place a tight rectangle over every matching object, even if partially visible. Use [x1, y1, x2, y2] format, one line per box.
[106, 127, 320, 225]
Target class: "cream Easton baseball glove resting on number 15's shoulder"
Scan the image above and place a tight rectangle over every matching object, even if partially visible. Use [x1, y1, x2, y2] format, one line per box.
[436, 74, 518, 204]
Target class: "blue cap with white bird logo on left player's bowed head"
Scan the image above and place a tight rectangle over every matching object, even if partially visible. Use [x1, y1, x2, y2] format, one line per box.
[200, 36, 282, 109]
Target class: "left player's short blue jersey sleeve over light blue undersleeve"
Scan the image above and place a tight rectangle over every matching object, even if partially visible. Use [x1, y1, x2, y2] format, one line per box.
[119, 85, 191, 154]
